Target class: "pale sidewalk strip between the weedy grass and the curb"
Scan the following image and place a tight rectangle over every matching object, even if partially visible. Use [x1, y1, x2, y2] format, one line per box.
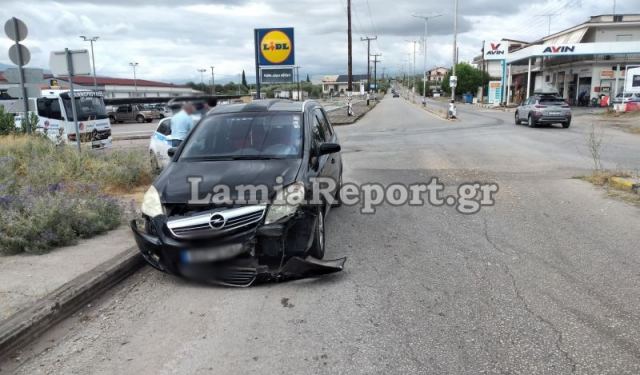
[0, 225, 135, 323]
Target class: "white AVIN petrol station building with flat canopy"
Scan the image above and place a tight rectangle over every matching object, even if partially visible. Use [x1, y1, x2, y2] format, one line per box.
[484, 14, 640, 105]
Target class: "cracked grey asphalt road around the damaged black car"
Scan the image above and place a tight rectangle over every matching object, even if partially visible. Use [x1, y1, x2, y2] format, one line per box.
[5, 97, 640, 374]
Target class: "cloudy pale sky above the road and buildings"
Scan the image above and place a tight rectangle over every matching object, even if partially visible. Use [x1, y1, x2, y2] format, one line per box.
[0, 0, 640, 82]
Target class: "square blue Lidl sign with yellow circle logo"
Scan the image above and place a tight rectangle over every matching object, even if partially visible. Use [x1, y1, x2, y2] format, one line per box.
[255, 27, 295, 66]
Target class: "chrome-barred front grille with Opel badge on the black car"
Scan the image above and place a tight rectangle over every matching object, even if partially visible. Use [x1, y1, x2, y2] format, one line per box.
[167, 205, 266, 239]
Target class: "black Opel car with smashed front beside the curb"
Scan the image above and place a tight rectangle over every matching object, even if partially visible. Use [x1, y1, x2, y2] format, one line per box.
[131, 100, 345, 286]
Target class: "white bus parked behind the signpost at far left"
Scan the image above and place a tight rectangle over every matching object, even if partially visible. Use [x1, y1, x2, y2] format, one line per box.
[0, 90, 111, 149]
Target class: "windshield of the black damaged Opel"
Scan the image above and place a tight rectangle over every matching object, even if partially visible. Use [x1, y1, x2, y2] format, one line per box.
[180, 112, 302, 160]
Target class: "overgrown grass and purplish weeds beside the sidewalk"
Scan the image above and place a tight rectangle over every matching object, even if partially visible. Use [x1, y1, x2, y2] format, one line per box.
[0, 135, 154, 254]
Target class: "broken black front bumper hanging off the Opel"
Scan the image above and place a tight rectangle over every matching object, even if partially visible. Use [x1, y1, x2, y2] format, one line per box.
[131, 210, 346, 286]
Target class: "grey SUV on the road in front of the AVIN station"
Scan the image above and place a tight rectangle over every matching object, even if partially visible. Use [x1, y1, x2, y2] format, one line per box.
[515, 94, 571, 128]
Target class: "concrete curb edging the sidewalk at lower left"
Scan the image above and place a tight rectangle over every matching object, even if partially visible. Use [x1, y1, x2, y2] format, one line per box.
[0, 247, 144, 359]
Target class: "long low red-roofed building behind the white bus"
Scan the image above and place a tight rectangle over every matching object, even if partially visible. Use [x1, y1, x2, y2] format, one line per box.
[0, 73, 202, 98]
